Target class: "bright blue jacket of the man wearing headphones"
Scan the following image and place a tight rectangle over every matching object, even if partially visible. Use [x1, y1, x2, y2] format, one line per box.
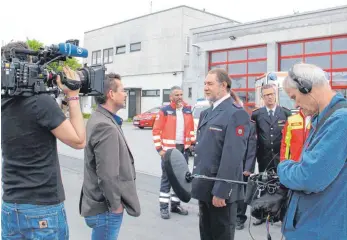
[277, 94, 347, 240]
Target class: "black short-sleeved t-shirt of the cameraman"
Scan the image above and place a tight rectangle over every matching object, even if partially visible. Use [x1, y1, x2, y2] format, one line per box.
[1, 94, 66, 205]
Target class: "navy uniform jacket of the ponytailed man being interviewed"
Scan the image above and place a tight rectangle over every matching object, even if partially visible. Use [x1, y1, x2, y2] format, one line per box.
[192, 98, 250, 203]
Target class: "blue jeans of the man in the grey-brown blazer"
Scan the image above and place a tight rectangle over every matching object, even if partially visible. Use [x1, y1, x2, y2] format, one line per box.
[85, 212, 123, 240]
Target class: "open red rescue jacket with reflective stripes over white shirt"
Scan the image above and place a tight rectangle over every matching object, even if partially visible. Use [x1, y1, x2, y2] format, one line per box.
[152, 103, 195, 152]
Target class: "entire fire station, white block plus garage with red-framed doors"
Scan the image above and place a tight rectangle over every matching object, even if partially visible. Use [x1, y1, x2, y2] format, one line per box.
[82, 5, 347, 119]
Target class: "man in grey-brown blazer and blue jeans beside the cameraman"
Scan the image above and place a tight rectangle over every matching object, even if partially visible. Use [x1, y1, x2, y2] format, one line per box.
[80, 73, 141, 240]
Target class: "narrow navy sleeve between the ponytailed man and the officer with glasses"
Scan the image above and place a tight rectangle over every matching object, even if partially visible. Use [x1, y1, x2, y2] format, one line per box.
[243, 120, 257, 173]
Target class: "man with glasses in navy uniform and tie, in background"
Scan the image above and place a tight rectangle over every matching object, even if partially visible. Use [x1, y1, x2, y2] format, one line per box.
[251, 84, 291, 225]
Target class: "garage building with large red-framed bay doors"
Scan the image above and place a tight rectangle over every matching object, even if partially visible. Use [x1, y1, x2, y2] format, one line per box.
[183, 5, 347, 110]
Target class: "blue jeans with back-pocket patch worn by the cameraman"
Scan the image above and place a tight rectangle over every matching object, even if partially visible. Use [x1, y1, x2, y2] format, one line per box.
[1, 202, 69, 240]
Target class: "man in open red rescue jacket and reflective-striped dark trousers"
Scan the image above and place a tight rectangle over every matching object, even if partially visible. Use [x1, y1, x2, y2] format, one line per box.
[152, 86, 194, 219]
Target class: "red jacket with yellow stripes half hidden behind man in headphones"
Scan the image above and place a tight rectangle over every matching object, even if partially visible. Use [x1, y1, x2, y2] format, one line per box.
[280, 110, 311, 162]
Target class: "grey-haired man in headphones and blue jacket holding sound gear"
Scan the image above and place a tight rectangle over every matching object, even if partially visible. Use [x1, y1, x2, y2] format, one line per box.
[277, 63, 347, 240]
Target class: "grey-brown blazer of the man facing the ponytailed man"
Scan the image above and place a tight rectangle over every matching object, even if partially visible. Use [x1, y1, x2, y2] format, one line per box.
[80, 106, 141, 217]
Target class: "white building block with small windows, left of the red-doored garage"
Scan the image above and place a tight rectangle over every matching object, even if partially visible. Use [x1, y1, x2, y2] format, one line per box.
[82, 6, 238, 119]
